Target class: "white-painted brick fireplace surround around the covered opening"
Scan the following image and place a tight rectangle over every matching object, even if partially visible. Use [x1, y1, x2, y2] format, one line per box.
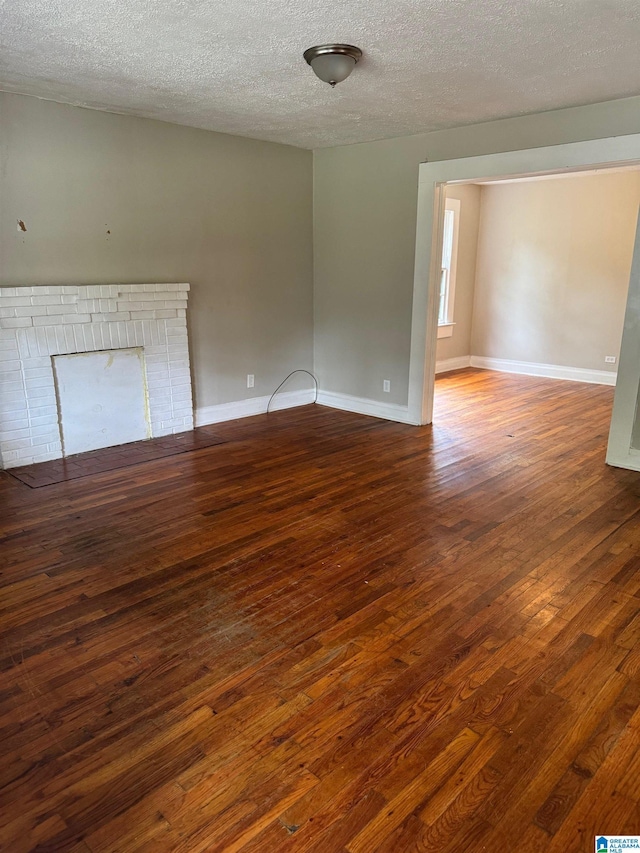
[0, 284, 193, 468]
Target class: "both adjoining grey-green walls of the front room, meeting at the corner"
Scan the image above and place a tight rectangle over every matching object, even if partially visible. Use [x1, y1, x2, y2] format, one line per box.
[6, 89, 640, 416]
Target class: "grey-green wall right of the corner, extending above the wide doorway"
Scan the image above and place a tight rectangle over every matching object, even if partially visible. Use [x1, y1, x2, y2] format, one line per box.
[314, 98, 640, 405]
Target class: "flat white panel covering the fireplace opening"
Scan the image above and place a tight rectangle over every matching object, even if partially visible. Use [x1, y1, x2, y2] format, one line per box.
[53, 347, 151, 456]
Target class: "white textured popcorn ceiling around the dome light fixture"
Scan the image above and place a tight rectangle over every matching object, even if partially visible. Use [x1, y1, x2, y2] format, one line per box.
[0, 0, 640, 148]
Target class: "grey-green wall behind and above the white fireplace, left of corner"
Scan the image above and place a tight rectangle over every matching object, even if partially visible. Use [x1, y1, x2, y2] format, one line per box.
[0, 93, 313, 407]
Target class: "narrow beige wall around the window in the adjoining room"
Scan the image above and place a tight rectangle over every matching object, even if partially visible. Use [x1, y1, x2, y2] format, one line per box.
[436, 184, 482, 361]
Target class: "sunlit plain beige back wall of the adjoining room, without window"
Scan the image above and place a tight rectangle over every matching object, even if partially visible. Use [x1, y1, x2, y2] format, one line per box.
[471, 172, 640, 372]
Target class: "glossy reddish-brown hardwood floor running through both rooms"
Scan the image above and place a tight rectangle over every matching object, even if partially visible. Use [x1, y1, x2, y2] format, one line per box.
[0, 370, 640, 853]
